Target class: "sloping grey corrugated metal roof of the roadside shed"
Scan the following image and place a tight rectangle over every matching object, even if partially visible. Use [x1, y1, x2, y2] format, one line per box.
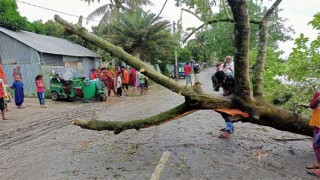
[0, 27, 101, 57]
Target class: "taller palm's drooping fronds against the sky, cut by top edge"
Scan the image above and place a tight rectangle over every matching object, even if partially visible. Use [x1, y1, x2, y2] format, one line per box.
[84, 0, 153, 24]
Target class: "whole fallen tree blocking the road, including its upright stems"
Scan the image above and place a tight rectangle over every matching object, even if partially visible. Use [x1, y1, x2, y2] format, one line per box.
[55, 0, 312, 135]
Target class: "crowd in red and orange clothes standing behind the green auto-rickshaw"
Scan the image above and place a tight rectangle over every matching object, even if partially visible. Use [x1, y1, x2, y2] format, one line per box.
[90, 63, 148, 97]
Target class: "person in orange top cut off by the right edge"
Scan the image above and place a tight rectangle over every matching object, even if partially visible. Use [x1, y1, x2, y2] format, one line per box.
[306, 89, 320, 177]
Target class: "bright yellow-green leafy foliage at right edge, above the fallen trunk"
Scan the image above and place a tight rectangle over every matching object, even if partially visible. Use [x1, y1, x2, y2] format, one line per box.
[278, 13, 320, 113]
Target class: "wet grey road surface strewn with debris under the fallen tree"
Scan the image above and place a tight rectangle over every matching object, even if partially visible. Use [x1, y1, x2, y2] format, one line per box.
[0, 70, 315, 180]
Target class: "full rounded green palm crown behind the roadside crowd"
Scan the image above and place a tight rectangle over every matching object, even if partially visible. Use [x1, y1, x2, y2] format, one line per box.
[108, 8, 177, 63]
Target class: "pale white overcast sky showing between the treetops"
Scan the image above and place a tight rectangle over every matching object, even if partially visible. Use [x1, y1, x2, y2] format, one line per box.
[17, 0, 320, 57]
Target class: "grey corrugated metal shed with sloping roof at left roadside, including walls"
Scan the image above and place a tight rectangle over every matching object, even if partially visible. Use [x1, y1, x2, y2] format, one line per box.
[0, 27, 101, 94]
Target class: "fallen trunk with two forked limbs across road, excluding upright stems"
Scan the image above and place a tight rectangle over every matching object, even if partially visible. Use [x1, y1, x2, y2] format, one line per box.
[55, 15, 312, 136]
